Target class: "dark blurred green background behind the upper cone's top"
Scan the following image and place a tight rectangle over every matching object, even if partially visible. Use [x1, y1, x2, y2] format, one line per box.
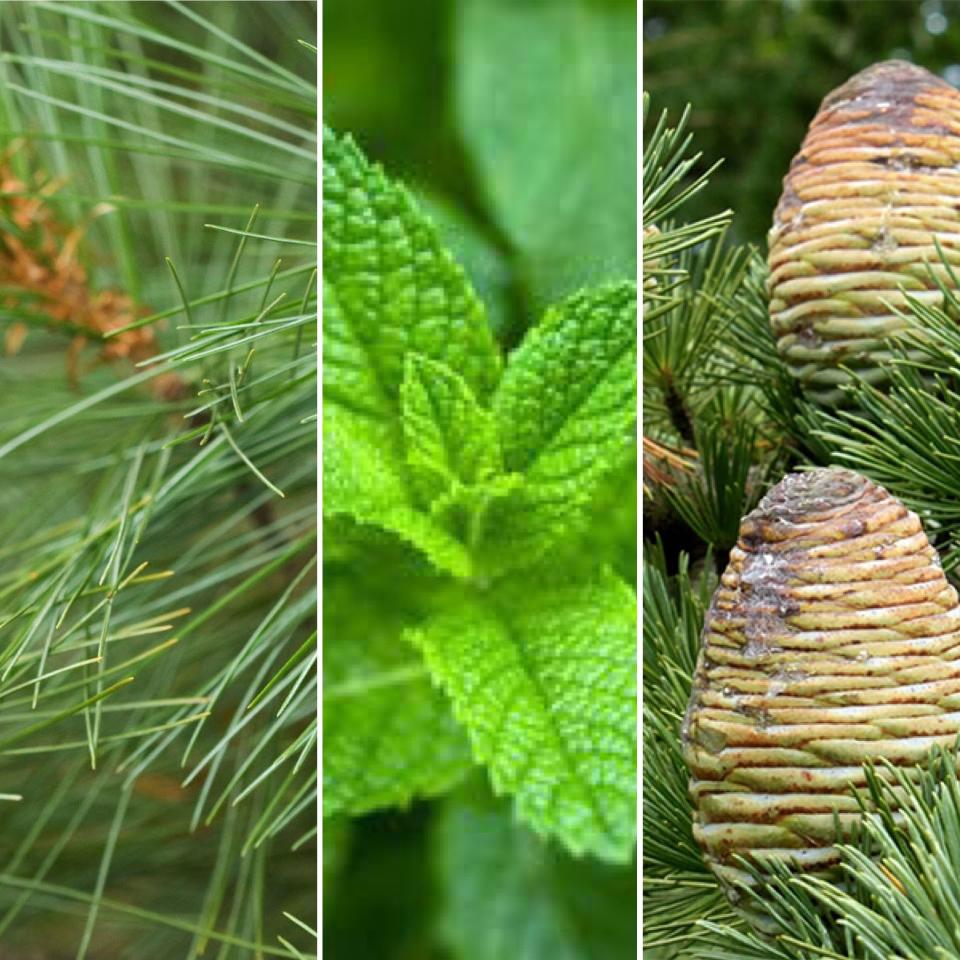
[643, 0, 960, 250]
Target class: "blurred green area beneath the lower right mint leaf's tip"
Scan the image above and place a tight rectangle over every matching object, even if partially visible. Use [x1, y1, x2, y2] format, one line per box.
[435, 802, 637, 960]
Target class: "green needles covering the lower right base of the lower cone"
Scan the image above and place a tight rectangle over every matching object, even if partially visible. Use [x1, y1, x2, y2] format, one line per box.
[701, 748, 960, 960]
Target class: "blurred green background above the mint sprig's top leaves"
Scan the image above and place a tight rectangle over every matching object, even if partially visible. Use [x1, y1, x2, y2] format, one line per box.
[323, 0, 637, 346]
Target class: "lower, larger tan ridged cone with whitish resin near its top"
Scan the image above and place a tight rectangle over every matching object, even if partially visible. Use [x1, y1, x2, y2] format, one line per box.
[683, 469, 960, 912]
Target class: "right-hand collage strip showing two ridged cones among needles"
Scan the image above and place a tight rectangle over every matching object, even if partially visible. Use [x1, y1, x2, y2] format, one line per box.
[641, 0, 960, 960]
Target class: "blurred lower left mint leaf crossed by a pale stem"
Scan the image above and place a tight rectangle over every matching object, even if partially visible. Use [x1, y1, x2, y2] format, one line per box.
[323, 584, 472, 817]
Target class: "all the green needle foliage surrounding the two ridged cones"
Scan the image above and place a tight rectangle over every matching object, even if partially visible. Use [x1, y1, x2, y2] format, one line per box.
[643, 92, 960, 960]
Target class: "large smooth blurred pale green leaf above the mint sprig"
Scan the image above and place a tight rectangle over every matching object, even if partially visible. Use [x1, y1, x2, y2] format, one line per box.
[455, 0, 637, 306]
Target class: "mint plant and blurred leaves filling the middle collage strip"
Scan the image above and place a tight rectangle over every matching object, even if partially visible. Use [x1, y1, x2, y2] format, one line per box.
[324, 2, 637, 960]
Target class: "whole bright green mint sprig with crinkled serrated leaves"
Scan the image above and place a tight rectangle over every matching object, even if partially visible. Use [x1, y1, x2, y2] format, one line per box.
[323, 131, 636, 862]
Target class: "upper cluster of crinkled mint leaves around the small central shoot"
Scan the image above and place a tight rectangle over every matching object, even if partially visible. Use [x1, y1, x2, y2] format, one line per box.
[324, 128, 636, 577]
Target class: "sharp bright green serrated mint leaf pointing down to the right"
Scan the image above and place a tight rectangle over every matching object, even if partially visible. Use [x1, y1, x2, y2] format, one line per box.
[410, 574, 636, 861]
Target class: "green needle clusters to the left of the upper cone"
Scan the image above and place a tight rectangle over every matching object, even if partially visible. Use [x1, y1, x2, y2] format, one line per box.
[643, 100, 782, 551]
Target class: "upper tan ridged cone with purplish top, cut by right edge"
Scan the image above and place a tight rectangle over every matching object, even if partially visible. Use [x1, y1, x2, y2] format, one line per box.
[768, 60, 960, 403]
